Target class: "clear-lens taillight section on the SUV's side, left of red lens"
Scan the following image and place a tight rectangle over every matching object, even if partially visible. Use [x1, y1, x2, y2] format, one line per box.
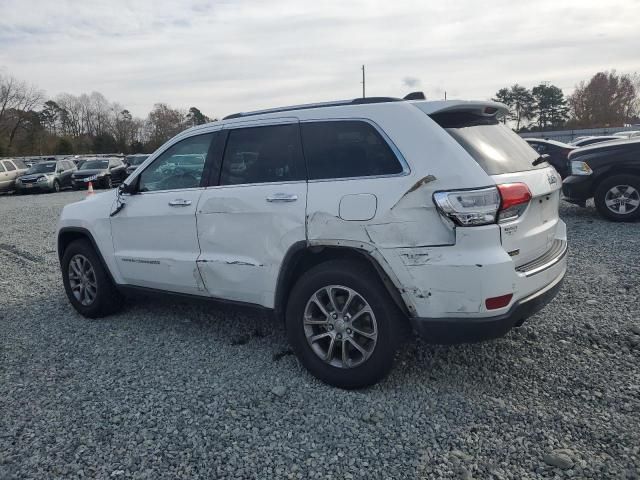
[433, 187, 500, 227]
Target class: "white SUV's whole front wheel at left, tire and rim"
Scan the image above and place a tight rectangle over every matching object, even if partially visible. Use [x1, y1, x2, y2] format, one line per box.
[61, 239, 123, 318]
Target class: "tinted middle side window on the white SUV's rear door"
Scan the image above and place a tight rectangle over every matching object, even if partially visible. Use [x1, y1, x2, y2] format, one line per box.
[220, 124, 305, 185]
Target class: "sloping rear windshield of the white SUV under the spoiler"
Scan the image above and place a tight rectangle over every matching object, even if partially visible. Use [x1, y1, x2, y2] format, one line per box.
[431, 112, 549, 175]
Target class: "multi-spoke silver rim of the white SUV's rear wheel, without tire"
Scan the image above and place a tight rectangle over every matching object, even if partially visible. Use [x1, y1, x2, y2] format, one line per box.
[303, 285, 378, 368]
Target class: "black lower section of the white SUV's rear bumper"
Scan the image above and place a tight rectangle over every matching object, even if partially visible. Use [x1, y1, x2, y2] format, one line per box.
[410, 270, 565, 344]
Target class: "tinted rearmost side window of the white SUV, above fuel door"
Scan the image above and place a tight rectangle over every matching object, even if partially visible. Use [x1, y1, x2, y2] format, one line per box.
[301, 120, 403, 180]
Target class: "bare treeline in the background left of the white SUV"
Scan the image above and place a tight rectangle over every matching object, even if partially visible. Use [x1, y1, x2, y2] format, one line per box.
[0, 71, 215, 157]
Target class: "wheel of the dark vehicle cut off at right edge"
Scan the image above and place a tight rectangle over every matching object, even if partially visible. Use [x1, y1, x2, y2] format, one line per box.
[593, 175, 640, 222]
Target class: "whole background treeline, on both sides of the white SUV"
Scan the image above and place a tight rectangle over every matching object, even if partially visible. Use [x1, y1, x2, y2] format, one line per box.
[0, 71, 640, 156]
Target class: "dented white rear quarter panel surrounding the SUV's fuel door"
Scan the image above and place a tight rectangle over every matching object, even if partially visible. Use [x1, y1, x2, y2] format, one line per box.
[301, 102, 498, 313]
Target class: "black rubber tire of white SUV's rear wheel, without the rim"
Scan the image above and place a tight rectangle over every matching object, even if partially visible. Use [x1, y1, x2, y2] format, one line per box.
[286, 260, 405, 389]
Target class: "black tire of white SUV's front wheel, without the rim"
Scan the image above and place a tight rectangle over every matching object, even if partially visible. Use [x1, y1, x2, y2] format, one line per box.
[61, 239, 124, 318]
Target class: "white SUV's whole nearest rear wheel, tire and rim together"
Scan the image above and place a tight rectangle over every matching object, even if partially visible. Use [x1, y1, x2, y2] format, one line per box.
[286, 260, 402, 389]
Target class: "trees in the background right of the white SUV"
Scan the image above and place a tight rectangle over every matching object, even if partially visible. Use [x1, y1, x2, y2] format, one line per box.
[493, 71, 640, 132]
